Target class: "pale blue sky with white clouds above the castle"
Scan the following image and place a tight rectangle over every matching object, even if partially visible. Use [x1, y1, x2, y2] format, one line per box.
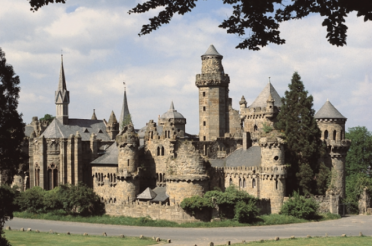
[0, 0, 372, 134]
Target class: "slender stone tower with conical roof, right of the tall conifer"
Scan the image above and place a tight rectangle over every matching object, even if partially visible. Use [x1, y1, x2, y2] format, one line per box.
[314, 100, 351, 198]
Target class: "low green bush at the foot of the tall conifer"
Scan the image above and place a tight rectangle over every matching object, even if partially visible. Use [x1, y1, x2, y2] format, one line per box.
[280, 192, 319, 220]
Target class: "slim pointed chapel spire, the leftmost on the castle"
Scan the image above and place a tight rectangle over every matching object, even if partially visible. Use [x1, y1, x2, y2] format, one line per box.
[55, 55, 70, 125]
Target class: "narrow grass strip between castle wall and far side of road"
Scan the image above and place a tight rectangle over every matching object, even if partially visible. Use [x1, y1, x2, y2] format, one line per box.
[14, 212, 340, 228]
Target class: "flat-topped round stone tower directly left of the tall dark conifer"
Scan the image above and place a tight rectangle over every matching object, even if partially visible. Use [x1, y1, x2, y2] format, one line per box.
[259, 137, 287, 213]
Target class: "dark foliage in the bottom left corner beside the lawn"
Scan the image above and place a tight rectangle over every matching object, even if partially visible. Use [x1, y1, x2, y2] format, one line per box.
[0, 186, 15, 246]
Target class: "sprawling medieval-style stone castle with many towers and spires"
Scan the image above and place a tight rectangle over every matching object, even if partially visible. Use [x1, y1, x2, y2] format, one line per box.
[10, 45, 350, 221]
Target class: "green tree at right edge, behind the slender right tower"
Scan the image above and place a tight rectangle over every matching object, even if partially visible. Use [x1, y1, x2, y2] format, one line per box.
[345, 126, 372, 212]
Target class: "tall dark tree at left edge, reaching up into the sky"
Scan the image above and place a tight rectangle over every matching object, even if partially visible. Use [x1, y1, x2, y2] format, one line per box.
[0, 48, 25, 182]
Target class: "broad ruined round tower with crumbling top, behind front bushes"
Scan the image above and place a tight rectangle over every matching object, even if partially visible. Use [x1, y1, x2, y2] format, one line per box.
[166, 142, 209, 204]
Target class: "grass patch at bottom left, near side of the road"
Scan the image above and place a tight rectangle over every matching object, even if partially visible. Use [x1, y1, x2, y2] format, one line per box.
[5, 231, 161, 246]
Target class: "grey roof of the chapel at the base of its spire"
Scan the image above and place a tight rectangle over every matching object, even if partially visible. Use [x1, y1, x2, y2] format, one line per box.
[42, 119, 111, 141]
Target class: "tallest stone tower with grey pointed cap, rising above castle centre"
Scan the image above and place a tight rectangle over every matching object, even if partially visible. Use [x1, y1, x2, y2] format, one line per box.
[195, 45, 230, 141]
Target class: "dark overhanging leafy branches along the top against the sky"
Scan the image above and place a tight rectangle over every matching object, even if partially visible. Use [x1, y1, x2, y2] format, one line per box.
[29, 0, 372, 50]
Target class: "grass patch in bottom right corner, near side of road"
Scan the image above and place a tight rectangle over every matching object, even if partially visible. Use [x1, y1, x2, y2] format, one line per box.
[228, 236, 372, 246]
